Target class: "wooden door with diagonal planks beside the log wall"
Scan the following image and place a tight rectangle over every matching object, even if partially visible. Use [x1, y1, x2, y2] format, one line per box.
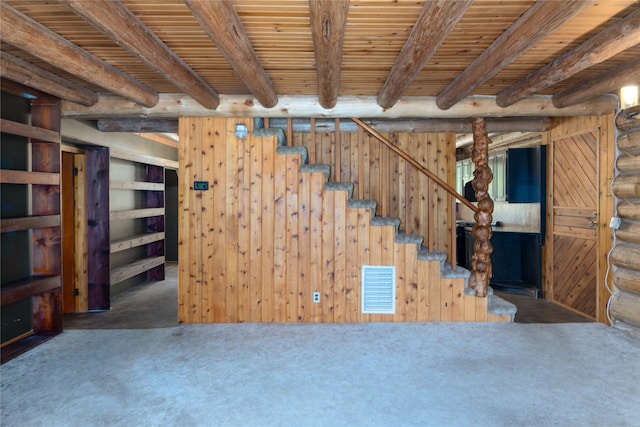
[550, 129, 599, 319]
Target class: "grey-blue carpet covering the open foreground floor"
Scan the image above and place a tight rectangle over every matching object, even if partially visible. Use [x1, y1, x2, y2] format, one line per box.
[1, 323, 640, 427]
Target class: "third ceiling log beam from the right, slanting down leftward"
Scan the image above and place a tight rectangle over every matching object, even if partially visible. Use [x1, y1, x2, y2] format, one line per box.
[436, 0, 592, 110]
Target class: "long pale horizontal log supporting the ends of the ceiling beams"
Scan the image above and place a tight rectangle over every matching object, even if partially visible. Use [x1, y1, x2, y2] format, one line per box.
[62, 94, 618, 120]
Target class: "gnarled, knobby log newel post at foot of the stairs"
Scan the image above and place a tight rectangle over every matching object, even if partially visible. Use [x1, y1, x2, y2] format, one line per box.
[469, 118, 493, 297]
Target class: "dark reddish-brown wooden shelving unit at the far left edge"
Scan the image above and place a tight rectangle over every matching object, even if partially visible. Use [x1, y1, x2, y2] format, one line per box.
[0, 98, 62, 346]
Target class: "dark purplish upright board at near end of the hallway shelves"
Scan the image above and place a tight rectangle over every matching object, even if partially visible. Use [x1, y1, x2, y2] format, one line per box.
[86, 147, 111, 310]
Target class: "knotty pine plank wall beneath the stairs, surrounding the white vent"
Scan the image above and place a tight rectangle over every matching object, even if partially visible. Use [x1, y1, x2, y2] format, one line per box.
[178, 118, 509, 323]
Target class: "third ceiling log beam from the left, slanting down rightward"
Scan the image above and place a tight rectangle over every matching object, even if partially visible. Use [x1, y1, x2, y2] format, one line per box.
[59, 0, 220, 109]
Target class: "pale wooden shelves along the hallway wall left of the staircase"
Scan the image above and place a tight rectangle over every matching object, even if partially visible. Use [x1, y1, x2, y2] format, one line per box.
[109, 149, 177, 286]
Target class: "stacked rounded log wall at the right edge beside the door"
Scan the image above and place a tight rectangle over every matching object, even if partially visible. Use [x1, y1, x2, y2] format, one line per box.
[609, 107, 640, 336]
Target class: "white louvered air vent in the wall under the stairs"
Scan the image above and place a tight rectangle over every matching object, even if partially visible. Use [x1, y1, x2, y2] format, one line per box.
[362, 265, 396, 314]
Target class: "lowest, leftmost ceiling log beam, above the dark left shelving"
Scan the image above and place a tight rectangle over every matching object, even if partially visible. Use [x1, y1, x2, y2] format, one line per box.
[0, 52, 98, 107]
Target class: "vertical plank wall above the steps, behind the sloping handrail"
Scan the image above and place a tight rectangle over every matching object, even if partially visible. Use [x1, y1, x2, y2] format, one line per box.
[289, 127, 455, 255]
